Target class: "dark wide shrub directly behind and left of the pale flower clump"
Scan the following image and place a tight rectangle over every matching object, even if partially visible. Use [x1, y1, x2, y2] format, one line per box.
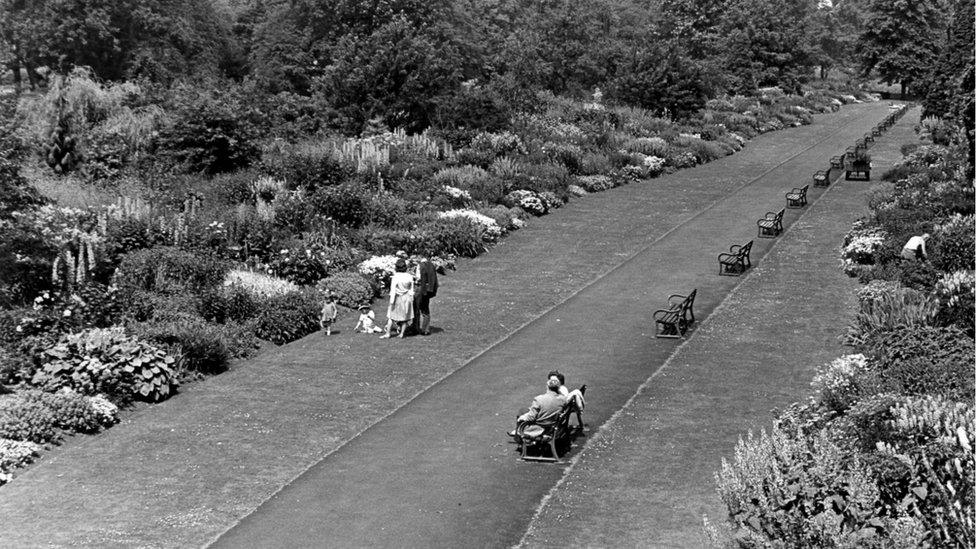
[115, 246, 228, 293]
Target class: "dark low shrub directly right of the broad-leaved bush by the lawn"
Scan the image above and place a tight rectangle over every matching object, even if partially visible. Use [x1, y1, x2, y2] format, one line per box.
[134, 319, 230, 374]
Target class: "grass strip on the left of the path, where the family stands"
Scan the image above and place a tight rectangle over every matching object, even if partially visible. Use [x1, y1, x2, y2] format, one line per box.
[0, 100, 883, 546]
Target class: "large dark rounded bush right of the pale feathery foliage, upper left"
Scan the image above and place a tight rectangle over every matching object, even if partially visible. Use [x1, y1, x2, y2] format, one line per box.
[154, 94, 259, 174]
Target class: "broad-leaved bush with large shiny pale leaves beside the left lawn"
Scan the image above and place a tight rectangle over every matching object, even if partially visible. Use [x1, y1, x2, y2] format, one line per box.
[31, 328, 178, 404]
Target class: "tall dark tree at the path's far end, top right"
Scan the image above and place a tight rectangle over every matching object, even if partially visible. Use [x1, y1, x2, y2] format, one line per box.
[858, 0, 948, 94]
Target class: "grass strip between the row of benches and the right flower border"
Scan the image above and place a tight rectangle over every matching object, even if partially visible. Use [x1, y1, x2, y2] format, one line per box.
[521, 105, 918, 547]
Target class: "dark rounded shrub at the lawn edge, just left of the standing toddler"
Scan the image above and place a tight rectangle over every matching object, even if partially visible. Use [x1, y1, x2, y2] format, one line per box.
[255, 290, 322, 345]
